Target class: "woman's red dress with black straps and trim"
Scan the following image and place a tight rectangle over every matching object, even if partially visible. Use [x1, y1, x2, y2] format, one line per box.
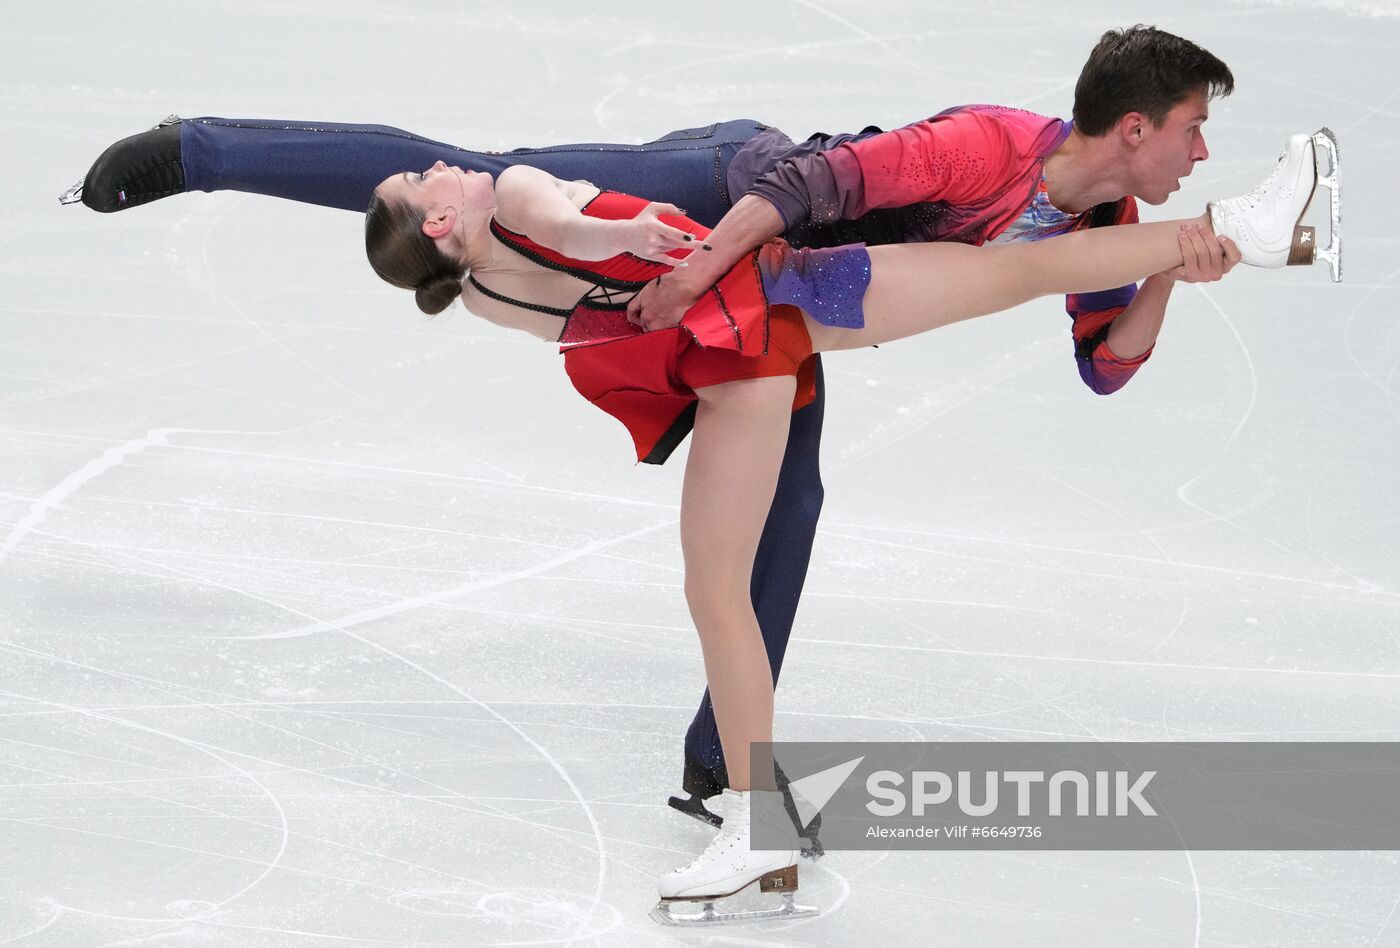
[469, 190, 816, 463]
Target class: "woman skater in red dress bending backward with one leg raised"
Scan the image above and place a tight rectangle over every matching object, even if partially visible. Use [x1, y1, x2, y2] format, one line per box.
[365, 136, 1316, 920]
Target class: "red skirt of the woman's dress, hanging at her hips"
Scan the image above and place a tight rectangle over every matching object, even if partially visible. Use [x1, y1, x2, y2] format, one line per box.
[560, 253, 816, 463]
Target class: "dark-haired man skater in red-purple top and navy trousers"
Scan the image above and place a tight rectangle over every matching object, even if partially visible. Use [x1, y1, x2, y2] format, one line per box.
[64, 25, 1239, 823]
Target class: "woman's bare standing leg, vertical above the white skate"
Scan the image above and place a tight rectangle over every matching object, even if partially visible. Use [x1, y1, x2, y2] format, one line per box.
[680, 375, 797, 790]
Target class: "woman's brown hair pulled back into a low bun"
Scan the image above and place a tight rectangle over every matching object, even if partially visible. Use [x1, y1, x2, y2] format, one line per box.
[364, 192, 466, 316]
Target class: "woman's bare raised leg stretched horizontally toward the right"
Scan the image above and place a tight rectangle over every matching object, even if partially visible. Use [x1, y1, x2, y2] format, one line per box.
[806, 214, 1210, 351]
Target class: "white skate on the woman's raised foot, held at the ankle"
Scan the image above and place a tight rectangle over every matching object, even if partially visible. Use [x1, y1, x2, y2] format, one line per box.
[1210, 129, 1341, 283]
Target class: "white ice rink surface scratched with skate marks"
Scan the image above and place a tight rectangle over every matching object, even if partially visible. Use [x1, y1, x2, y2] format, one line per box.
[0, 0, 1400, 948]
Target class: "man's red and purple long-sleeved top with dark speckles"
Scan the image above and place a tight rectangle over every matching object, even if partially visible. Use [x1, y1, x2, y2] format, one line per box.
[729, 105, 1152, 395]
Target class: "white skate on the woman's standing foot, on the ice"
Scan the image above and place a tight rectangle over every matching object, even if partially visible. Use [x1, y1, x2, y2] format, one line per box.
[651, 790, 816, 926]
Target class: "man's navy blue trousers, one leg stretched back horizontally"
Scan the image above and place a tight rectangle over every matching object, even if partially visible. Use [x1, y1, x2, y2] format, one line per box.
[181, 118, 826, 793]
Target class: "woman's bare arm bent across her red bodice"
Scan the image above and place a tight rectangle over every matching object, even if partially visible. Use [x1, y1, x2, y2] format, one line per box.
[496, 165, 696, 265]
